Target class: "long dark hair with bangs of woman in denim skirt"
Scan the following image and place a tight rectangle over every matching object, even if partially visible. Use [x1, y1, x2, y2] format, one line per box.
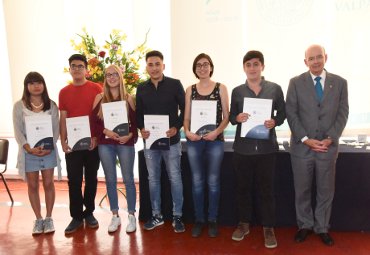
[22, 72, 51, 111]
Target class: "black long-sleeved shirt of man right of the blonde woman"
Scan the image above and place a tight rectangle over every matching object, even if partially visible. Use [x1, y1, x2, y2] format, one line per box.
[136, 76, 185, 145]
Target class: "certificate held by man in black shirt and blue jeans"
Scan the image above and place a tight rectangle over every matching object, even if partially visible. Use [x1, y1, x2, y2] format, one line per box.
[144, 115, 170, 150]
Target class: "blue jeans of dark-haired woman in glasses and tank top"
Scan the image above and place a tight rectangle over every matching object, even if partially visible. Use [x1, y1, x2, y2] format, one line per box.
[187, 140, 224, 222]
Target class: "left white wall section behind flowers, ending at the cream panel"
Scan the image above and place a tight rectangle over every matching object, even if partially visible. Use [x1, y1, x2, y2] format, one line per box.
[0, 0, 171, 175]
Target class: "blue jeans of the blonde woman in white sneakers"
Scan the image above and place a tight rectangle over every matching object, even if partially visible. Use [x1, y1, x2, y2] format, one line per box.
[98, 144, 136, 213]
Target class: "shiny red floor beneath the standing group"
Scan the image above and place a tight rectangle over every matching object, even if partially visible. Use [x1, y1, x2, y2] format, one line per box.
[0, 180, 370, 255]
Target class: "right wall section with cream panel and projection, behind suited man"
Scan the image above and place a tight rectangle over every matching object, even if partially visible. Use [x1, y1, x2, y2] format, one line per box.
[171, 0, 370, 134]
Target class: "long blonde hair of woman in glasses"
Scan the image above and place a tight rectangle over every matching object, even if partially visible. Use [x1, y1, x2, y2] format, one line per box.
[98, 65, 129, 119]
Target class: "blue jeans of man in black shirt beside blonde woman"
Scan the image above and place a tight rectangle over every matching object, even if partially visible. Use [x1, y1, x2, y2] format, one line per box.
[144, 142, 183, 216]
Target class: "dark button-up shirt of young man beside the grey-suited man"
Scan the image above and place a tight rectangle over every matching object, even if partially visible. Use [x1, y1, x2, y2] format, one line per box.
[230, 80, 286, 155]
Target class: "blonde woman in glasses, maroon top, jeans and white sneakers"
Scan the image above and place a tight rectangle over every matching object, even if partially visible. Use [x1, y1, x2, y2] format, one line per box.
[92, 65, 137, 233]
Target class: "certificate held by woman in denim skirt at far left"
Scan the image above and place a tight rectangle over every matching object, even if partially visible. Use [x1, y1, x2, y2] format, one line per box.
[25, 115, 54, 150]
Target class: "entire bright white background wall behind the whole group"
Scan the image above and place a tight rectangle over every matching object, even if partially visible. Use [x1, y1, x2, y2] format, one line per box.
[0, 0, 370, 175]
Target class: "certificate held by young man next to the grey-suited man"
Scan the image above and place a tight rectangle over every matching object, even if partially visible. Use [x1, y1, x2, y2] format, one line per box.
[240, 97, 272, 139]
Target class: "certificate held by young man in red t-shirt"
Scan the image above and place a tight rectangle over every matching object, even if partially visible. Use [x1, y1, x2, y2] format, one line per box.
[66, 116, 91, 151]
